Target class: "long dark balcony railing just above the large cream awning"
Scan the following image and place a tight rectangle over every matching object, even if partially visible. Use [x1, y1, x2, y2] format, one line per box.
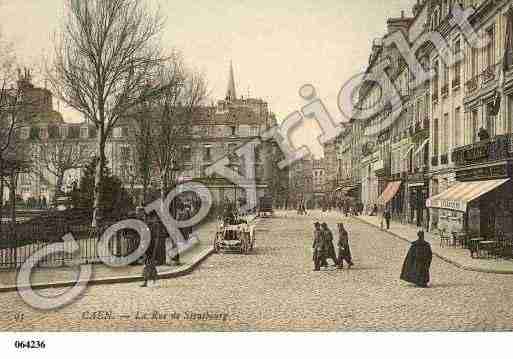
[452, 134, 513, 166]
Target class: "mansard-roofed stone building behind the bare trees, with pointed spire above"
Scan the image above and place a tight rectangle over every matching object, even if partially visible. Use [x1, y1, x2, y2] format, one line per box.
[5, 63, 280, 210]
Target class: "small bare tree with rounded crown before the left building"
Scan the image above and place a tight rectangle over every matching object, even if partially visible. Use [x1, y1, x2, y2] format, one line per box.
[31, 138, 91, 200]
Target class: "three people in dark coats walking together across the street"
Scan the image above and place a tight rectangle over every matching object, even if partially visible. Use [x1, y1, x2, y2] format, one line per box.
[312, 222, 354, 271]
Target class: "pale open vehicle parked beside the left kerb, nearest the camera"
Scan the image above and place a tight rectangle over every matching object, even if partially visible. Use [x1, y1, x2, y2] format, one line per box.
[214, 223, 255, 254]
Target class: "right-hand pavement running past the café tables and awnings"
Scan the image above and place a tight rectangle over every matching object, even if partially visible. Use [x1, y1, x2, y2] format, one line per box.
[351, 216, 513, 274]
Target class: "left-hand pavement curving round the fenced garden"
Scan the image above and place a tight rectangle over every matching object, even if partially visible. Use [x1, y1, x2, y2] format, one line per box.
[0, 221, 223, 293]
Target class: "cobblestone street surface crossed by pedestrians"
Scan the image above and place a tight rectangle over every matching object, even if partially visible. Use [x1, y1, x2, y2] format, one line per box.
[0, 212, 513, 331]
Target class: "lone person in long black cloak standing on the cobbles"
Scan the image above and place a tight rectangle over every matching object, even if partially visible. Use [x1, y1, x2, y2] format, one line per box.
[401, 231, 433, 288]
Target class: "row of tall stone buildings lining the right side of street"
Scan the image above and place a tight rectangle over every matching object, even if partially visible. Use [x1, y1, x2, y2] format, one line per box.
[328, 0, 513, 239]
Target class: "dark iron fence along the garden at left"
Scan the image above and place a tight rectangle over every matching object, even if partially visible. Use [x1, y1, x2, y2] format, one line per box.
[0, 213, 167, 270]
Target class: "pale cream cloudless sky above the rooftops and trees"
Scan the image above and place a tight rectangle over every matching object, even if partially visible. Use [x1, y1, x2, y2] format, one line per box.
[0, 0, 416, 156]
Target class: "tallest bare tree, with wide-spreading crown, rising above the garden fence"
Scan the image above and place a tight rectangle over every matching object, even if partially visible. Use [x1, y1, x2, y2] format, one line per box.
[48, 0, 163, 224]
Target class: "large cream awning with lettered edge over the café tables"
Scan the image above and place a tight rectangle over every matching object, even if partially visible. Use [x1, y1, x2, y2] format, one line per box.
[426, 178, 509, 212]
